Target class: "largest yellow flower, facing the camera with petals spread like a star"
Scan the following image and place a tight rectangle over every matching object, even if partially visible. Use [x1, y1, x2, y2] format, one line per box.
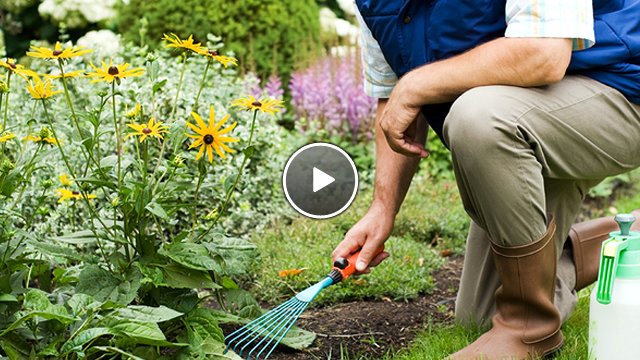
[187, 105, 239, 163]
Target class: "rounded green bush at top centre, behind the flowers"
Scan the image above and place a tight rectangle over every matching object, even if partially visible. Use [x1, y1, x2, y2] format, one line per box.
[119, 0, 320, 79]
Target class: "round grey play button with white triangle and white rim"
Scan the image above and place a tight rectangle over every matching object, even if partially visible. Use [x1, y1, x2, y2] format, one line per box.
[282, 143, 358, 219]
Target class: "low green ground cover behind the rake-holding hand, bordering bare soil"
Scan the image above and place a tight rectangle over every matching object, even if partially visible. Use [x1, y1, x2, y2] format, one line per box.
[251, 177, 468, 305]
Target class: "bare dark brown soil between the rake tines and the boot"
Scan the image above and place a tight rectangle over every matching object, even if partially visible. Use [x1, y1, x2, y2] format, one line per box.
[258, 257, 462, 360]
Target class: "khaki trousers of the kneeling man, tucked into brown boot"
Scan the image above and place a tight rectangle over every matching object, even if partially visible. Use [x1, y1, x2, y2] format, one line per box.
[444, 76, 640, 325]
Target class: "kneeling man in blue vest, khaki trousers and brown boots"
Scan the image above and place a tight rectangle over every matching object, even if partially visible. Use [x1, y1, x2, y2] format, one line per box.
[333, 0, 640, 359]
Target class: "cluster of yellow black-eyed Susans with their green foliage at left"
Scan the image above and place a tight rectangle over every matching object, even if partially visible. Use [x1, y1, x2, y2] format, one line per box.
[0, 34, 313, 359]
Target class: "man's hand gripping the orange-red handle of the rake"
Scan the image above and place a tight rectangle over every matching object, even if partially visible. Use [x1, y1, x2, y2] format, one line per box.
[332, 205, 395, 274]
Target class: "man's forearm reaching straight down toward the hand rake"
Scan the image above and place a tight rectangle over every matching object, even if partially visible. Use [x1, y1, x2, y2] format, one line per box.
[372, 99, 427, 216]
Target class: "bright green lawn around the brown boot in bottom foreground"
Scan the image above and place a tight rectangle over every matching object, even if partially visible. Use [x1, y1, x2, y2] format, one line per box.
[384, 290, 589, 360]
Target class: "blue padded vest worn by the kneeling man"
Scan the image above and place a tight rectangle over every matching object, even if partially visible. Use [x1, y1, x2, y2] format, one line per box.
[356, 0, 640, 143]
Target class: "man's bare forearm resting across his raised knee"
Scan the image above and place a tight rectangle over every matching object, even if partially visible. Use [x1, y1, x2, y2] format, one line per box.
[398, 38, 571, 106]
